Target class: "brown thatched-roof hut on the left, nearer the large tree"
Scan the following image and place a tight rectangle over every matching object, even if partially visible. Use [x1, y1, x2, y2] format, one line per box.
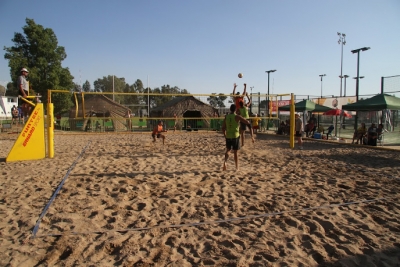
[69, 95, 131, 130]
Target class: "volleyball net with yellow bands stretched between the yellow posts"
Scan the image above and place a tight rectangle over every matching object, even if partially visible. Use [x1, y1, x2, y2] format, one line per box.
[49, 90, 291, 132]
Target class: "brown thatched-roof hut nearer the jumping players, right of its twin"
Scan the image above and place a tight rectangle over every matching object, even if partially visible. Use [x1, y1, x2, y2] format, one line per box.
[150, 96, 218, 130]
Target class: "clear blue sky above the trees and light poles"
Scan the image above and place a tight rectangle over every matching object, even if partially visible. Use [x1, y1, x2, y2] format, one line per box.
[0, 0, 400, 99]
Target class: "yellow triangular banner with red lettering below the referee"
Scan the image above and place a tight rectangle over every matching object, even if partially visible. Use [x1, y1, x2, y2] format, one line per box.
[6, 103, 46, 162]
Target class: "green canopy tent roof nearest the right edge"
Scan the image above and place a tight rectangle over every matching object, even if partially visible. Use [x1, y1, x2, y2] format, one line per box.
[342, 94, 400, 111]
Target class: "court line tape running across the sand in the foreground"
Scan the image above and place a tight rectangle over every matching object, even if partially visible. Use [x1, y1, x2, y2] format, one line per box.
[36, 198, 390, 237]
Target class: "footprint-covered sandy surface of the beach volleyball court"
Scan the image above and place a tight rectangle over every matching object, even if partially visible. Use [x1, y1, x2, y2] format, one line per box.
[0, 132, 400, 266]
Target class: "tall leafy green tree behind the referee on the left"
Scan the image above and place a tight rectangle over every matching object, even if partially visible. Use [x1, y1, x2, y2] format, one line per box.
[4, 18, 74, 113]
